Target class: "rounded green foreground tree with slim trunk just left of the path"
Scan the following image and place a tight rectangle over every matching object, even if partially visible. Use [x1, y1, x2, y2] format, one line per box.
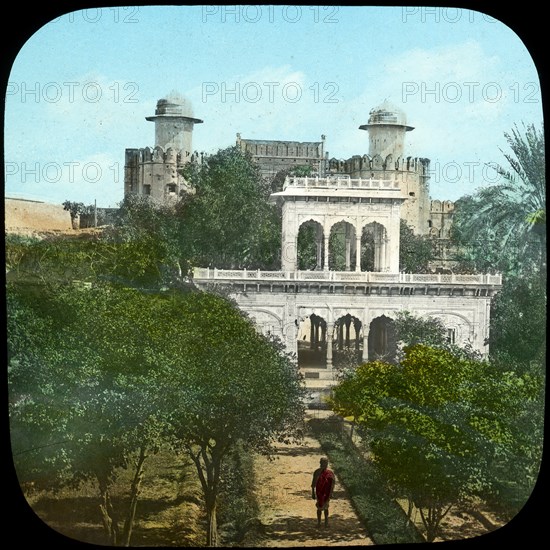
[157, 293, 304, 546]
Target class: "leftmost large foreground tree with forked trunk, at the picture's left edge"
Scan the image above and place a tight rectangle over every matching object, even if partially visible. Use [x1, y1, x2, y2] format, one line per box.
[8, 285, 175, 546]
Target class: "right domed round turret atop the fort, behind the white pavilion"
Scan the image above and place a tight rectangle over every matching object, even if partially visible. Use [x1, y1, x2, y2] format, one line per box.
[359, 101, 414, 159]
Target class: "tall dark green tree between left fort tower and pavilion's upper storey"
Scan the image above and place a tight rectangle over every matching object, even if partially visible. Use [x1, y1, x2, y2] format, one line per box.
[182, 147, 281, 269]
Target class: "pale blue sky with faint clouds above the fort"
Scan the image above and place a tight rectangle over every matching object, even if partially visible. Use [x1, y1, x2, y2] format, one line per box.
[4, 5, 543, 207]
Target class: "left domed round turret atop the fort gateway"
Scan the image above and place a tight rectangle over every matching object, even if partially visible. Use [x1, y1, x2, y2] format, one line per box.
[145, 92, 202, 157]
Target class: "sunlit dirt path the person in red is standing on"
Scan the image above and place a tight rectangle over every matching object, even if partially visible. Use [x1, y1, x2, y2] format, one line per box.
[251, 420, 373, 547]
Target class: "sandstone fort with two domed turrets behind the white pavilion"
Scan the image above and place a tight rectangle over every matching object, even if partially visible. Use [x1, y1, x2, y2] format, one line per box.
[124, 92, 454, 240]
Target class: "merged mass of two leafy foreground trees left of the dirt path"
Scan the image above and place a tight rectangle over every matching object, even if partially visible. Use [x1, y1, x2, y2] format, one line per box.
[8, 284, 303, 545]
